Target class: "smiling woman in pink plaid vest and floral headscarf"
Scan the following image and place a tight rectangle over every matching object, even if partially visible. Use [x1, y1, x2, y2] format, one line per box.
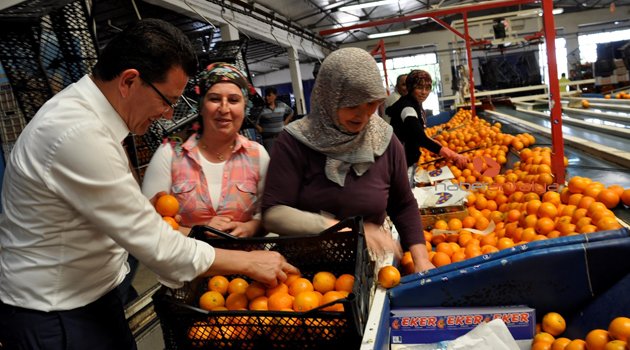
[142, 63, 269, 237]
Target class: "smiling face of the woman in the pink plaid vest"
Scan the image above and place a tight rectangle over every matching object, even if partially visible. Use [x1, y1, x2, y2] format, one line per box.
[201, 82, 245, 136]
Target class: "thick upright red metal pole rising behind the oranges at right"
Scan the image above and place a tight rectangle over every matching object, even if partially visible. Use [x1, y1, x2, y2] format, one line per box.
[542, 0, 566, 185]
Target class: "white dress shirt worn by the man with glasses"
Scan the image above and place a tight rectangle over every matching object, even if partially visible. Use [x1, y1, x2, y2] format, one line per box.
[0, 75, 215, 311]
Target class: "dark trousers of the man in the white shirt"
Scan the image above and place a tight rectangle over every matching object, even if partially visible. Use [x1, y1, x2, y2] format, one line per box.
[0, 289, 137, 350]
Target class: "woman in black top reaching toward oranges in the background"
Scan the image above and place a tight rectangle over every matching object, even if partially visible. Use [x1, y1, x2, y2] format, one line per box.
[385, 69, 468, 168]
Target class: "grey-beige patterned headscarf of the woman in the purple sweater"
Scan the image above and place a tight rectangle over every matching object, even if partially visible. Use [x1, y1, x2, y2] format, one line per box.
[286, 48, 393, 187]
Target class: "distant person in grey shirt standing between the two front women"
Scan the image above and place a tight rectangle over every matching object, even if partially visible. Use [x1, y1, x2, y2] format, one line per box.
[258, 87, 293, 152]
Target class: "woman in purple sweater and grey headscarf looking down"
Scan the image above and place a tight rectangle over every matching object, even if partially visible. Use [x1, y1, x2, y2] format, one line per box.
[262, 48, 433, 271]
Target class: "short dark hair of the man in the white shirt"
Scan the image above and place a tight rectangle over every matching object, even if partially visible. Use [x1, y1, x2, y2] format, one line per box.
[92, 18, 197, 83]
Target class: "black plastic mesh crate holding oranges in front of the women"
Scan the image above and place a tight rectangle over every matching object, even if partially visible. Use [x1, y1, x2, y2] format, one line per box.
[153, 218, 374, 349]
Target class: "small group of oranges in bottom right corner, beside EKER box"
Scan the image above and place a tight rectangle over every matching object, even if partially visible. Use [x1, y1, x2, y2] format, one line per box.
[532, 312, 630, 350]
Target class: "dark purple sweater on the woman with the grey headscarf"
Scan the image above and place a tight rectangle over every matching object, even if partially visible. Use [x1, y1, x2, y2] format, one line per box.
[262, 131, 424, 249]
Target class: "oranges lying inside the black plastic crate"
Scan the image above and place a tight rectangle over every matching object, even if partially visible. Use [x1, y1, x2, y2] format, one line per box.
[199, 271, 354, 312]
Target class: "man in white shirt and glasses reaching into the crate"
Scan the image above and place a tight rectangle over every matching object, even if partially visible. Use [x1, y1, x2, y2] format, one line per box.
[0, 19, 297, 349]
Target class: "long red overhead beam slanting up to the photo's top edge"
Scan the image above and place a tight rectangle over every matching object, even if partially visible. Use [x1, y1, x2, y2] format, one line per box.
[319, 0, 537, 36]
